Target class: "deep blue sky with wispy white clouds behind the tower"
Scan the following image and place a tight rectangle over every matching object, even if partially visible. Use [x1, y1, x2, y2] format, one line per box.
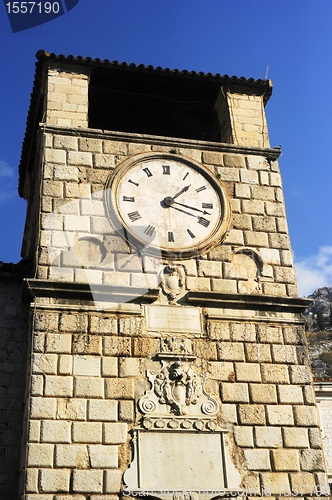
[0, 0, 332, 295]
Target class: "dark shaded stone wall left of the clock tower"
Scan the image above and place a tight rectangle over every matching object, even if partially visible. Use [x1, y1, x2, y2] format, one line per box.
[0, 273, 28, 500]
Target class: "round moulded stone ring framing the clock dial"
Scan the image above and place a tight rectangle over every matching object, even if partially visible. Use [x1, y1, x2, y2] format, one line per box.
[105, 151, 231, 260]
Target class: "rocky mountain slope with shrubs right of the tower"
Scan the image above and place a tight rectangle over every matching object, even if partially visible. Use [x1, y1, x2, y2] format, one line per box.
[304, 286, 332, 379]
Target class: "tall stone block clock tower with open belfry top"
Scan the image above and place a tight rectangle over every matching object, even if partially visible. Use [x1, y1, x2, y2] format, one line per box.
[16, 51, 329, 500]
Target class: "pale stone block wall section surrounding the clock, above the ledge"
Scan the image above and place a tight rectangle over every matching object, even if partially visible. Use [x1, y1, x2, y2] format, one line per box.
[36, 127, 297, 296]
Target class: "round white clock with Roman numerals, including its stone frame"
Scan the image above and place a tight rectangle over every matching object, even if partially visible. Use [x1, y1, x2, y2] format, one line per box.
[106, 153, 229, 257]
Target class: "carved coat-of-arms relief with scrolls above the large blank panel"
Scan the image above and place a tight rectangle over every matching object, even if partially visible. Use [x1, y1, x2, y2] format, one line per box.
[139, 337, 218, 417]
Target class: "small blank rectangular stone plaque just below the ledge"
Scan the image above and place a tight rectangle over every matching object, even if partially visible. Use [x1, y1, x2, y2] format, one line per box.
[145, 304, 203, 336]
